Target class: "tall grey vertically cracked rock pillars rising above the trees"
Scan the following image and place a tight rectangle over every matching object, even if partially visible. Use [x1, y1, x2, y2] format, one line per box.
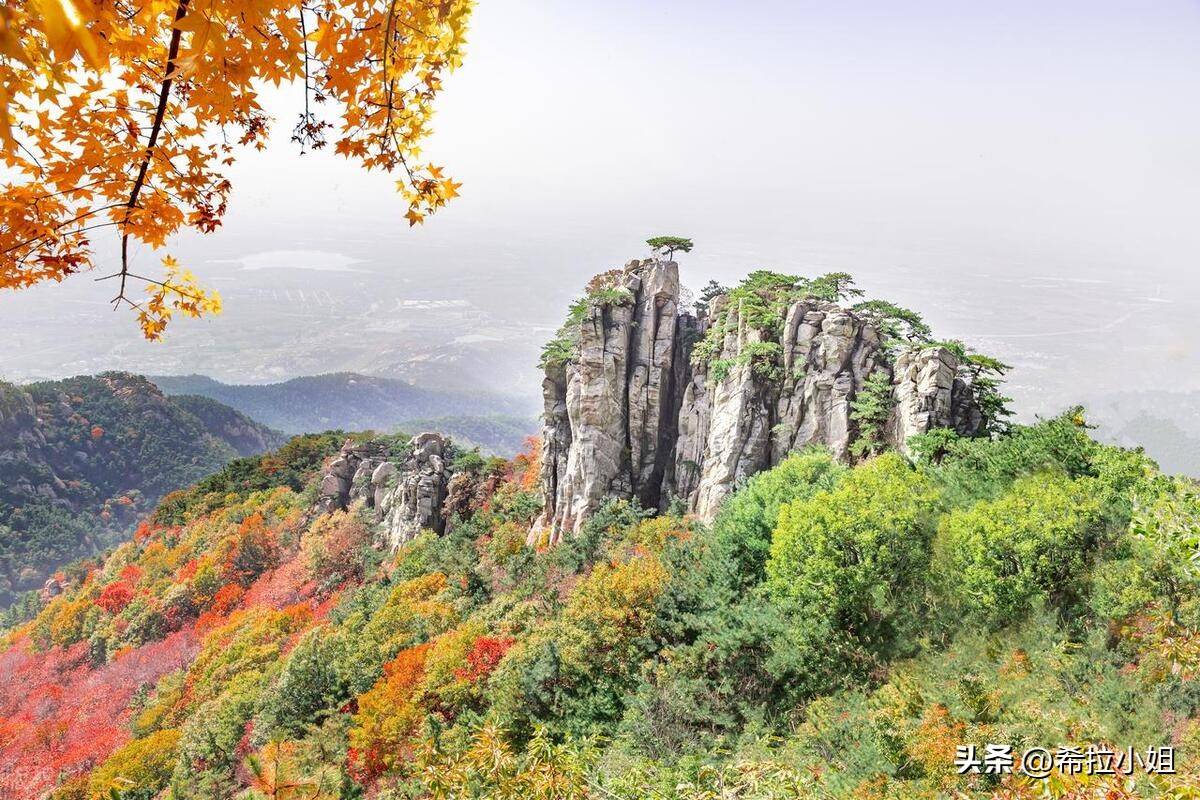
[530, 260, 983, 541]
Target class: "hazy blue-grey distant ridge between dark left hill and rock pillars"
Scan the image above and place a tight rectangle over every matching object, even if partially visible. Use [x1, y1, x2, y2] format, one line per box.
[151, 372, 534, 435]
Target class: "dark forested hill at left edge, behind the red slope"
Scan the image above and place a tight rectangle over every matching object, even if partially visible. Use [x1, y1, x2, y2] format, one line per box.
[0, 372, 283, 606]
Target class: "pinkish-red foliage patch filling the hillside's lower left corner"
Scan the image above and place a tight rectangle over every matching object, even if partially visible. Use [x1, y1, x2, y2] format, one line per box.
[0, 628, 198, 800]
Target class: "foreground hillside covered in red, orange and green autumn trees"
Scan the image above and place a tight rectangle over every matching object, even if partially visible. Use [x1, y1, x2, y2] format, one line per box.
[0, 409, 1200, 800]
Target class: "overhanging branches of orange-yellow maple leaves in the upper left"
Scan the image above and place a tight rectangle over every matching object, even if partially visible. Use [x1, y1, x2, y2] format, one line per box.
[0, 0, 474, 338]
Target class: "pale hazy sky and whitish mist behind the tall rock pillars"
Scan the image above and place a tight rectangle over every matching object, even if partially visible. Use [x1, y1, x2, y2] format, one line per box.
[0, 0, 1200, 419]
